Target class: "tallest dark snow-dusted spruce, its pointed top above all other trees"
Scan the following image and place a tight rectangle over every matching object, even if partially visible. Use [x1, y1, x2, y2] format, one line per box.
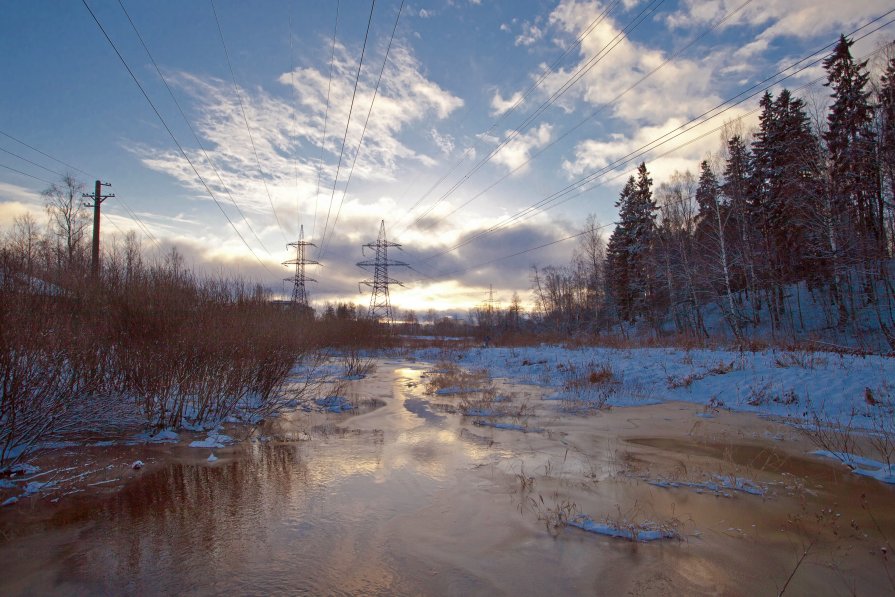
[824, 35, 885, 259]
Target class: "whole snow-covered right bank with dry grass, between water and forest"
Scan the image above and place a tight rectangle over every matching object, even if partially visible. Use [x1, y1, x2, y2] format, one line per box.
[416, 345, 895, 483]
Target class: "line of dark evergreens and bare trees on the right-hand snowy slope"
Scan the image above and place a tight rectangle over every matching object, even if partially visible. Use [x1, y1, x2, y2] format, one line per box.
[532, 36, 895, 349]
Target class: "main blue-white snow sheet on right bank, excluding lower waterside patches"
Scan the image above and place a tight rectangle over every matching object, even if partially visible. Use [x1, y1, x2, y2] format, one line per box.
[432, 345, 895, 423]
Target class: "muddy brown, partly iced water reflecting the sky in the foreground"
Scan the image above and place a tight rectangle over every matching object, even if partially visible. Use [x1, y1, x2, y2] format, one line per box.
[0, 360, 895, 595]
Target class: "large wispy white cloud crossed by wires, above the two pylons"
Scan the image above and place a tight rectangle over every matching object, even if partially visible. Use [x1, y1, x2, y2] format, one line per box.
[132, 45, 463, 242]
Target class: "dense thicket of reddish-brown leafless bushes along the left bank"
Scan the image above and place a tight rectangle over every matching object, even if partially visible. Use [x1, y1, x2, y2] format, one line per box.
[0, 236, 326, 466]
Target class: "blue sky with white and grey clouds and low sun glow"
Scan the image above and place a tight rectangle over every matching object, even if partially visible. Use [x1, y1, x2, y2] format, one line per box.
[0, 0, 895, 313]
